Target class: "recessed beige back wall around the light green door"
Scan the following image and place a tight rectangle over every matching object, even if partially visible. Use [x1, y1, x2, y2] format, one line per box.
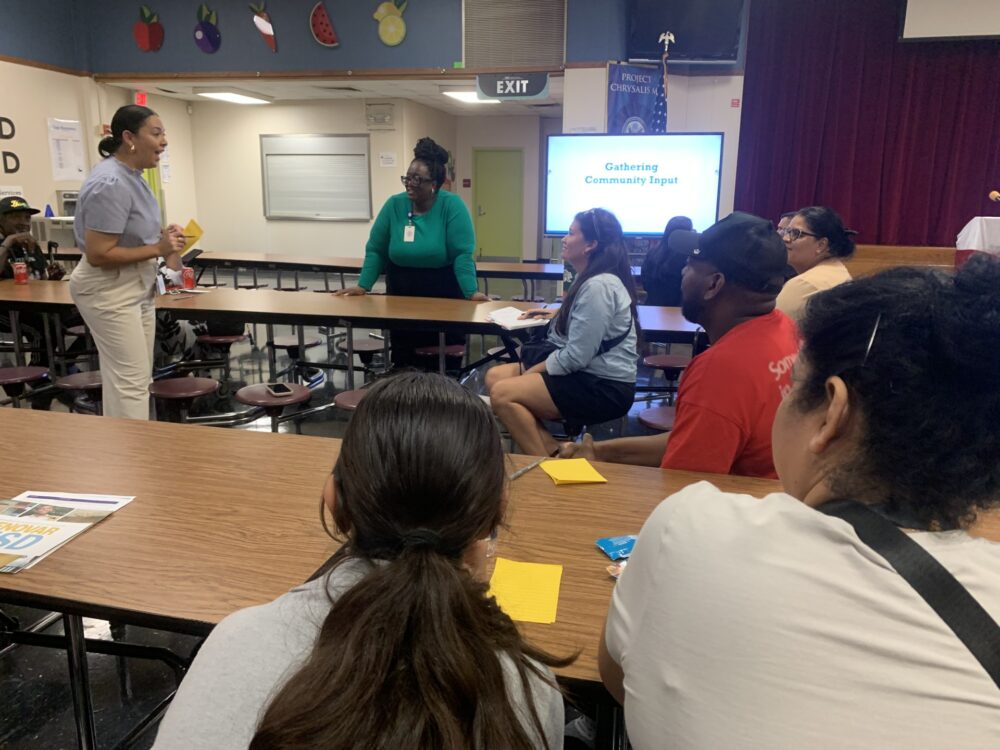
[455, 115, 542, 258]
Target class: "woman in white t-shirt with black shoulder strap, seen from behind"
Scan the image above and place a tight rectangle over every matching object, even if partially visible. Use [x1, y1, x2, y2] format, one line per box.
[598, 256, 1000, 750]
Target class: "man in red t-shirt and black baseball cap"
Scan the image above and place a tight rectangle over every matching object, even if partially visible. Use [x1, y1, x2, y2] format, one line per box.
[560, 212, 799, 479]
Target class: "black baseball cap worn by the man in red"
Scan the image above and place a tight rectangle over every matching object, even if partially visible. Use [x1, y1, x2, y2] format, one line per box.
[667, 211, 788, 294]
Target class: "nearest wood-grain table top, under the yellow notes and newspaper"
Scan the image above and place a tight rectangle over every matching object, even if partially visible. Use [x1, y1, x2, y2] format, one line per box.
[0, 409, 1000, 682]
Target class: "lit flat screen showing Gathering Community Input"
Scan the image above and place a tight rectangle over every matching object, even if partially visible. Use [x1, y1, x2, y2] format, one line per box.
[544, 133, 722, 236]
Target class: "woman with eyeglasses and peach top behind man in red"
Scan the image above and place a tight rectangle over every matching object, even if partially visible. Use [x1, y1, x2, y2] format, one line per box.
[775, 206, 857, 321]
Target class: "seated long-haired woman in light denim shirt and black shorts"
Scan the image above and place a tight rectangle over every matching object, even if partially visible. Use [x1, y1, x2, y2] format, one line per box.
[486, 208, 638, 456]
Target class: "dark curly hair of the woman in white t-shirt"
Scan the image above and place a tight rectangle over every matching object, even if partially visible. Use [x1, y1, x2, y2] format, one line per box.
[793, 254, 1000, 528]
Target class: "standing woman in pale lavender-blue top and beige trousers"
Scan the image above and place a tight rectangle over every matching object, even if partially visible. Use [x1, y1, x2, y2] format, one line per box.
[70, 105, 184, 419]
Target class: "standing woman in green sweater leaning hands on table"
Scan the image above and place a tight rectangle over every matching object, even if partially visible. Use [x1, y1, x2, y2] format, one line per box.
[335, 138, 489, 367]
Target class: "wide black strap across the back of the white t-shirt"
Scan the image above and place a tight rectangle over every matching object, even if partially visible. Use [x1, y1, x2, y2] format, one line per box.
[819, 500, 1000, 688]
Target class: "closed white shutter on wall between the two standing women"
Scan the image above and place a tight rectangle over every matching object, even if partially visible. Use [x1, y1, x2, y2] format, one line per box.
[260, 135, 372, 221]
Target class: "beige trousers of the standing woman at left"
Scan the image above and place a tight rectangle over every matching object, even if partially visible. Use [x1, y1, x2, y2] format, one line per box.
[69, 258, 156, 420]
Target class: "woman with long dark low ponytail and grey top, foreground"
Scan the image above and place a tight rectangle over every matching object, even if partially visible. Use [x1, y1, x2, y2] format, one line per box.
[155, 372, 572, 750]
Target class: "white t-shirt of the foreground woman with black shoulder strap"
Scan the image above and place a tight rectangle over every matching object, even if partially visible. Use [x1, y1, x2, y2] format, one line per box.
[606, 482, 1000, 750]
